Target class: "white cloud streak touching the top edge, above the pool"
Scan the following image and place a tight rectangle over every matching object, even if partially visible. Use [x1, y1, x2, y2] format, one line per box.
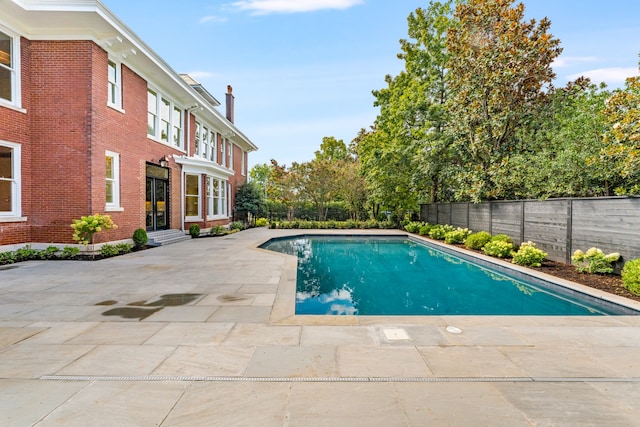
[231, 0, 364, 15]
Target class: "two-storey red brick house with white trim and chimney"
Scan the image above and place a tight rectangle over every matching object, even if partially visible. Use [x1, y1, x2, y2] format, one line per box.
[0, 0, 257, 251]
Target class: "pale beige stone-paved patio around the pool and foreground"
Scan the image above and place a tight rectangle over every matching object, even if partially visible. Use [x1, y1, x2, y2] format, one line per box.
[0, 229, 640, 427]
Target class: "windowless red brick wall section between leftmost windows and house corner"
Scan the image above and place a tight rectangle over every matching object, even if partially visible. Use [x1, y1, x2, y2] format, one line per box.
[29, 41, 94, 243]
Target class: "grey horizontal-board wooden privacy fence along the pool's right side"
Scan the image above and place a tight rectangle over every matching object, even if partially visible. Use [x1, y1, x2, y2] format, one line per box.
[420, 197, 640, 263]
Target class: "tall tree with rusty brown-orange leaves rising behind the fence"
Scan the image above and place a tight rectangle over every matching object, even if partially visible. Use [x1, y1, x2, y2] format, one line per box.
[447, 0, 562, 201]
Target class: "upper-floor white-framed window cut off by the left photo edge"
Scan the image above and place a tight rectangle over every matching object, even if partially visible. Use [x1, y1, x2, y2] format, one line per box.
[0, 28, 21, 107]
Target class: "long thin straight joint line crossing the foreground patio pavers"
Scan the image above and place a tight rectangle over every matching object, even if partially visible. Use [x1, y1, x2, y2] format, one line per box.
[40, 375, 640, 383]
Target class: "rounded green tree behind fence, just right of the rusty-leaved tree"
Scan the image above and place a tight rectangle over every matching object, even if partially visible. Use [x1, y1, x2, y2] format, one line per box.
[496, 78, 611, 199]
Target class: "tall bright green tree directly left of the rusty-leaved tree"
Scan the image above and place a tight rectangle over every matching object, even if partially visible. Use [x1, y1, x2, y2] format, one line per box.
[359, 1, 452, 214]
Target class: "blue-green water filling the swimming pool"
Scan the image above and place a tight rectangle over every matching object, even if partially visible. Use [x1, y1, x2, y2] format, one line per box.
[261, 235, 638, 315]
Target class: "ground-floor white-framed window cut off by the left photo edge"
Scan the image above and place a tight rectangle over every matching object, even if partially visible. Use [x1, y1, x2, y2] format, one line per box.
[0, 141, 22, 218]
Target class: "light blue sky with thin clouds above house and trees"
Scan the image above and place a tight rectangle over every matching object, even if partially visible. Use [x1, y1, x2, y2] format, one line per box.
[102, 0, 640, 168]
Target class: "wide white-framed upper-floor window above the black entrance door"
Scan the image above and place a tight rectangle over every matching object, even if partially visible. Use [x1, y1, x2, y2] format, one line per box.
[147, 89, 184, 148]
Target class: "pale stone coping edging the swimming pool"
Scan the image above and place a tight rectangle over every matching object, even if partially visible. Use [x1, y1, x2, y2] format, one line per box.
[254, 229, 640, 326]
